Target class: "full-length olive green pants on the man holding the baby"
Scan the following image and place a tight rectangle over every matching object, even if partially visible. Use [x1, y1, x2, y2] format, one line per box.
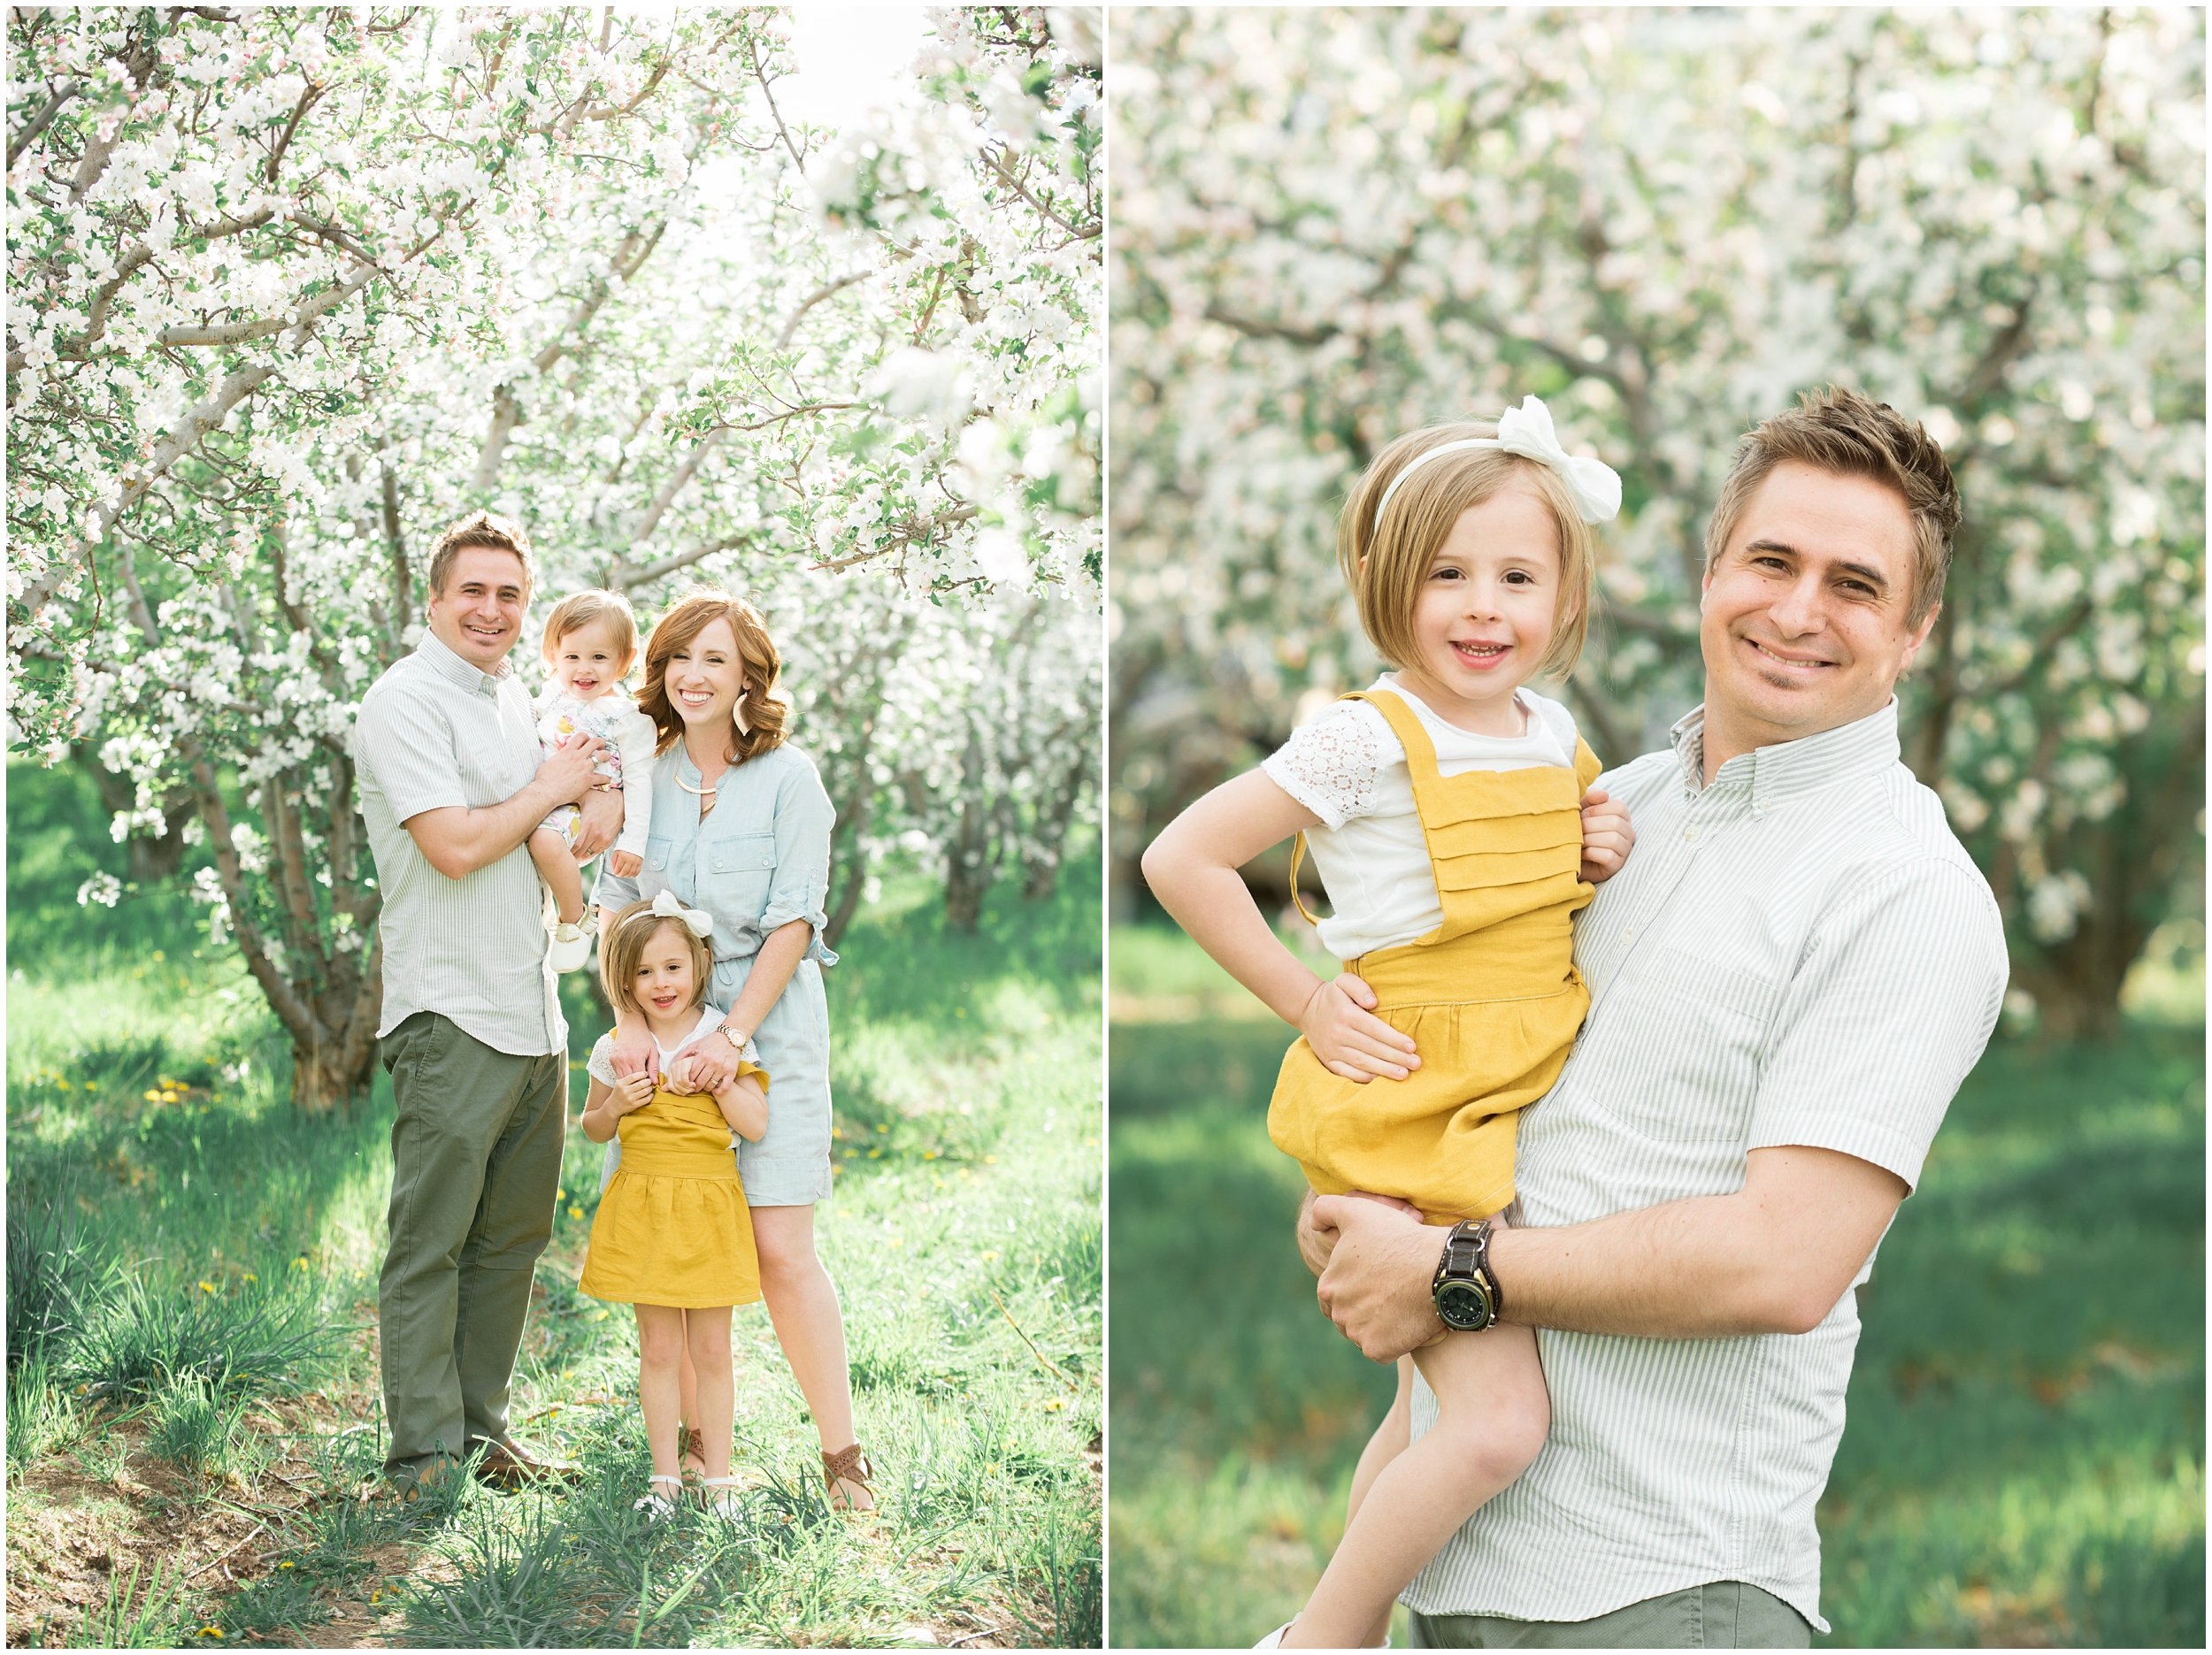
[376, 1011, 569, 1478]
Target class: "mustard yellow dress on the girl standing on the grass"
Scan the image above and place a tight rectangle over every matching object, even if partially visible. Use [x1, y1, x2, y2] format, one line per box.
[578, 1062, 768, 1310]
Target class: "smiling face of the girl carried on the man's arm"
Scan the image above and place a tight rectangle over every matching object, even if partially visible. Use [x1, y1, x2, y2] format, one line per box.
[1398, 487, 1562, 737]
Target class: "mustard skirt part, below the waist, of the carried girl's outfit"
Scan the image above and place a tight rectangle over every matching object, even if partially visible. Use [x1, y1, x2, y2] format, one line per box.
[1268, 927, 1591, 1223]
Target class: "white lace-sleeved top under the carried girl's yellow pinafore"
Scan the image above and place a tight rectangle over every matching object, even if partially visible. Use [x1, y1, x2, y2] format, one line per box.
[1261, 672, 1575, 961]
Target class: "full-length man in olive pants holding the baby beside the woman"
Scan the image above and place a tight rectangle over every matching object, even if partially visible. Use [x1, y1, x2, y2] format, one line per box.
[354, 511, 622, 1498]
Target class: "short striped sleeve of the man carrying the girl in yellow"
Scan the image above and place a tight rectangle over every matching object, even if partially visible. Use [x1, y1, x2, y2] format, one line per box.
[1747, 859, 2008, 1186]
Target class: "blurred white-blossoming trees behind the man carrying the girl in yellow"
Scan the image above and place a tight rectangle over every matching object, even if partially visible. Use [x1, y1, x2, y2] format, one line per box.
[1109, 11, 2206, 1033]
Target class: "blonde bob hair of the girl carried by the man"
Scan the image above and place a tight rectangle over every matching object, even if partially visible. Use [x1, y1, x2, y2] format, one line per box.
[1336, 423, 1597, 677]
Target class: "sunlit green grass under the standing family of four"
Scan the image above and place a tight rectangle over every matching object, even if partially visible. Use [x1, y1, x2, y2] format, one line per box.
[7, 858, 1104, 1648]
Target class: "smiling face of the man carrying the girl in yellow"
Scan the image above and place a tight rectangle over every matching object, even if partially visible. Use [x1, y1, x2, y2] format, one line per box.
[1699, 460, 1936, 774]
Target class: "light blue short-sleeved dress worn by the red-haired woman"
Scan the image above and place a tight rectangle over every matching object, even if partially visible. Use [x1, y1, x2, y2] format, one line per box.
[593, 741, 836, 1206]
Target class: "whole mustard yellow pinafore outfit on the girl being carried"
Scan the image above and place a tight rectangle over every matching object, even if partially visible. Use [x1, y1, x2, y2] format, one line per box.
[1268, 690, 1600, 1223]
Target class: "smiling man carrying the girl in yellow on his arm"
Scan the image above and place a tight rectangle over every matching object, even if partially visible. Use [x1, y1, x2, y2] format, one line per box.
[1299, 389, 2007, 1648]
